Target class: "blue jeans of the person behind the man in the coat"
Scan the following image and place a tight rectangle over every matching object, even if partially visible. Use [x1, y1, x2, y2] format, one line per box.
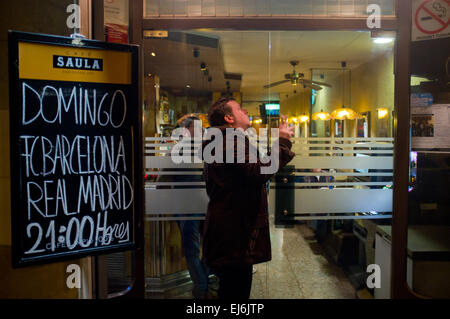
[177, 220, 209, 299]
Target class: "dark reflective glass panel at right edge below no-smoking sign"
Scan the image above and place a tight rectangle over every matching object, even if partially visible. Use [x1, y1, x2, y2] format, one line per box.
[405, 38, 450, 298]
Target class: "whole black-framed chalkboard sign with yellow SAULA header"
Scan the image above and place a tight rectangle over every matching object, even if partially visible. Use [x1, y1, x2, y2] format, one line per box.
[9, 31, 143, 267]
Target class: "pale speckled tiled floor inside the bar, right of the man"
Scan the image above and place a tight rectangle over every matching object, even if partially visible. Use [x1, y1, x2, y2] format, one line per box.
[251, 225, 356, 299]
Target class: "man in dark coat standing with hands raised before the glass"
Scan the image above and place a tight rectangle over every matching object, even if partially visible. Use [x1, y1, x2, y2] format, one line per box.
[203, 98, 294, 299]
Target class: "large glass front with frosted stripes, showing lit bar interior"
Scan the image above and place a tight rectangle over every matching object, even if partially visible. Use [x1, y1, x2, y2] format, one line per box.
[144, 28, 394, 298]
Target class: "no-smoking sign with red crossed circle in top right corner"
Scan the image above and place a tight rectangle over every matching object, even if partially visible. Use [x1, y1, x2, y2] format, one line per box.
[412, 0, 450, 41]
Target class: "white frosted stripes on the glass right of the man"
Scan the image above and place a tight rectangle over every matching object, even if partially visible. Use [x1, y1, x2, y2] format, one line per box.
[269, 138, 393, 220]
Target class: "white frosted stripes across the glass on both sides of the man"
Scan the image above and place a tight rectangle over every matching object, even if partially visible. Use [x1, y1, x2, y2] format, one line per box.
[145, 138, 393, 221]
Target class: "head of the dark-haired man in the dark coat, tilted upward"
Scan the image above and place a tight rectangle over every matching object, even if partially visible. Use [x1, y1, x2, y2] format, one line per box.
[208, 97, 250, 131]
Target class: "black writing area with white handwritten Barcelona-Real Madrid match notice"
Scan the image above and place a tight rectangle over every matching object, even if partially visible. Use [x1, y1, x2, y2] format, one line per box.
[19, 82, 134, 256]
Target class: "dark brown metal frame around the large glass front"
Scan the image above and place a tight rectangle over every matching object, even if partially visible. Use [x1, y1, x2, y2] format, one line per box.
[132, 0, 419, 298]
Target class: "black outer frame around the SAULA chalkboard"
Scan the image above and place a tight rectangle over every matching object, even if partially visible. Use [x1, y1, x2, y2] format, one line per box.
[8, 31, 144, 268]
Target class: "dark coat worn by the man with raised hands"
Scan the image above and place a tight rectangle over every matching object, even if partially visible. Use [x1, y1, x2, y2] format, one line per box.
[203, 127, 294, 268]
